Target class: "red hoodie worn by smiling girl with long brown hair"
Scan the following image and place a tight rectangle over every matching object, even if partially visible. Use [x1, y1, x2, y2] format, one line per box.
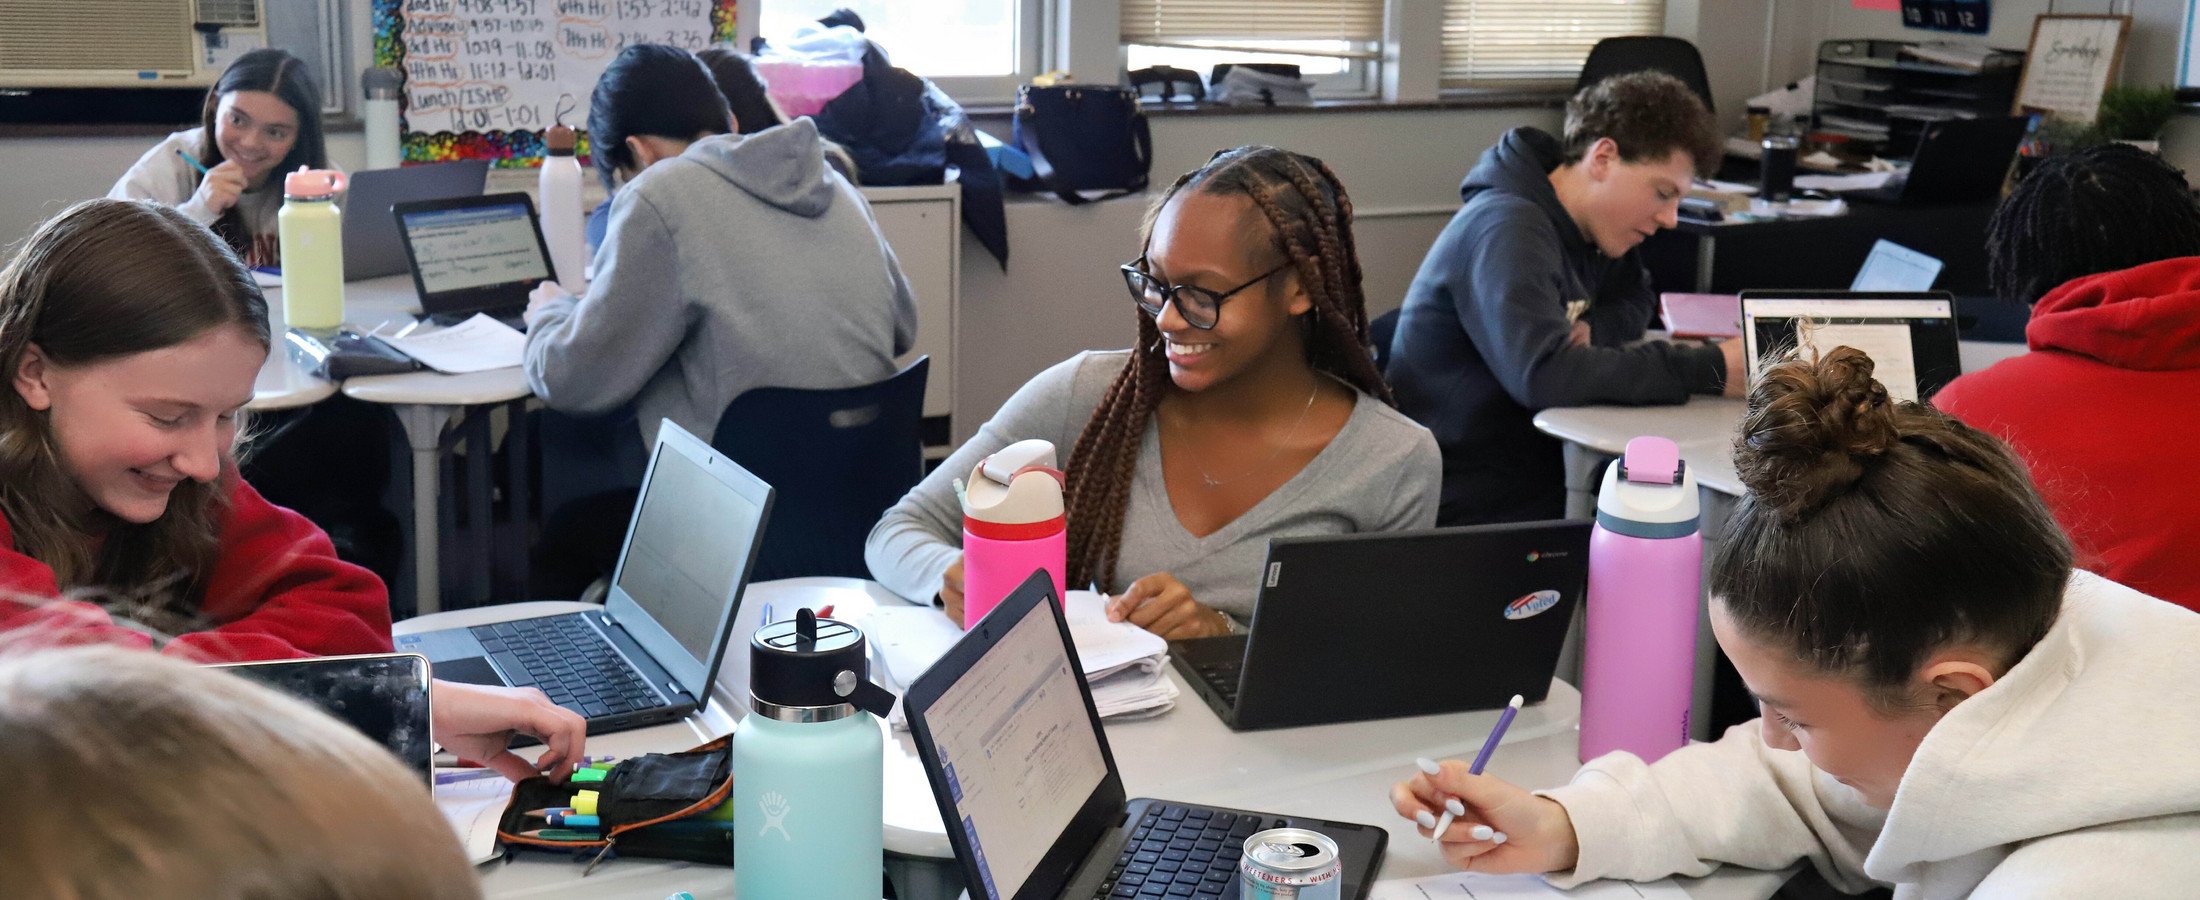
[0, 473, 389, 662]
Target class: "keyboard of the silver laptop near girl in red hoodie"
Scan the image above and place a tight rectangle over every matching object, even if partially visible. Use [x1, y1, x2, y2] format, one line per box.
[469, 616, 660, 720]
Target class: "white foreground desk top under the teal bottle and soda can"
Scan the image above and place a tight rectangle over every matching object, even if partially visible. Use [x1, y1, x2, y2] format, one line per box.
[396, 579, 1786, 900]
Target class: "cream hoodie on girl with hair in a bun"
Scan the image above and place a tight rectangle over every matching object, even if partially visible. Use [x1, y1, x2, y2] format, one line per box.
[1542, 572, 2200, 900]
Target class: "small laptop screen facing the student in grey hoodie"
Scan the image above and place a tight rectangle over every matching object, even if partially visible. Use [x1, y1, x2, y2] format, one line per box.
[398, 198, 550, 295]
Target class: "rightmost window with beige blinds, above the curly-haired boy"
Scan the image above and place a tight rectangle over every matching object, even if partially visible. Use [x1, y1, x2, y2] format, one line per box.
[1443, 0, 1665, 88]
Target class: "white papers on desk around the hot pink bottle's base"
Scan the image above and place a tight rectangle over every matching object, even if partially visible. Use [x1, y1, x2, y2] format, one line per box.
[856, 590, 1177, 728]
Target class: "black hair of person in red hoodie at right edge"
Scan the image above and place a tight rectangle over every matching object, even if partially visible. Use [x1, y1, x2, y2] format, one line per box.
[1987, 143, 2200, 306]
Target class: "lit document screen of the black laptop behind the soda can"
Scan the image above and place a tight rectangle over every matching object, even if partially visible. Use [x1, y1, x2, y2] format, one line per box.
[922, 601, 1109, 900]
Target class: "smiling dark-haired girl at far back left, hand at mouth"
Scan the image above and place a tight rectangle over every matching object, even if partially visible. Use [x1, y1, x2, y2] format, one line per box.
[108, 48, 328, 266]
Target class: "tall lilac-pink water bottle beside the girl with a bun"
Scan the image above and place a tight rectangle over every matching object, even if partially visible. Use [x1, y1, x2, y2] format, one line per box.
[1582, 436, 1703, 761]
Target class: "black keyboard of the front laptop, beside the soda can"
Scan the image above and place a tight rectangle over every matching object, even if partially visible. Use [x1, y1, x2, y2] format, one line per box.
[1093, 803, 1283, 900]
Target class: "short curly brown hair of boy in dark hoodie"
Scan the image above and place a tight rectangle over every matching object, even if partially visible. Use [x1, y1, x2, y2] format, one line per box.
[1564, 73, 1723, 176]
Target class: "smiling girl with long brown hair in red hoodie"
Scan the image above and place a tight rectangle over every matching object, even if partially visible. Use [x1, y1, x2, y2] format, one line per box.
[0, 200, 389, 660]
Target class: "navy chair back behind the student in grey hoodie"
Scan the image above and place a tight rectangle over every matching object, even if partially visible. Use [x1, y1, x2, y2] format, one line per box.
[711, 356, 933, 581]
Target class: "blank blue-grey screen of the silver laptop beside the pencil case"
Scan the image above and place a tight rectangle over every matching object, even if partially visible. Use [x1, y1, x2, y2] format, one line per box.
[605, 420, 772, 702]
